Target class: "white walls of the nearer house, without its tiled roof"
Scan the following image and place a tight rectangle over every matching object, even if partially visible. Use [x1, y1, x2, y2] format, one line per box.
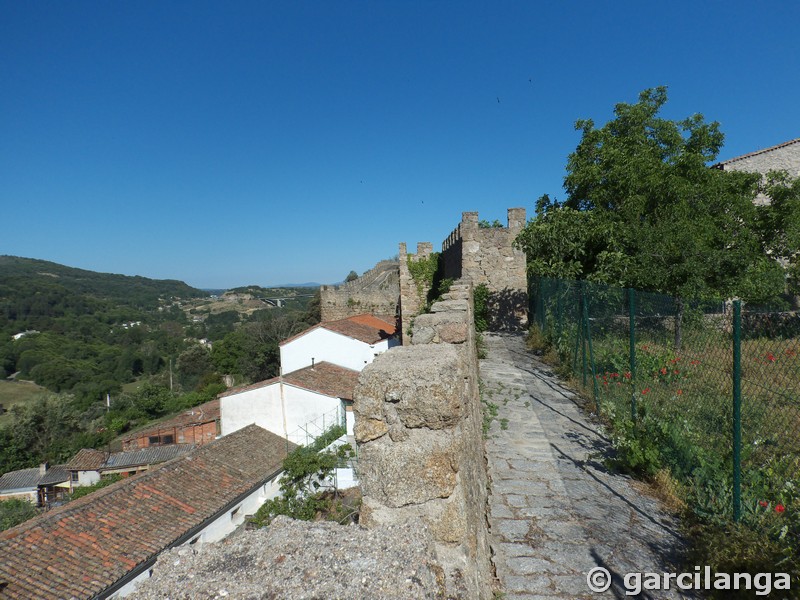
[220, 382, 342, 437]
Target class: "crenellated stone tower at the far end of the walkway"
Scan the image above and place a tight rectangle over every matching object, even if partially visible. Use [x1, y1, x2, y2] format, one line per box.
[442, 208, 528, 331]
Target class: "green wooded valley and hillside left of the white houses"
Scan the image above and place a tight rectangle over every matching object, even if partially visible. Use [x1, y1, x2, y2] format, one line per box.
[0, 256, 319, 473]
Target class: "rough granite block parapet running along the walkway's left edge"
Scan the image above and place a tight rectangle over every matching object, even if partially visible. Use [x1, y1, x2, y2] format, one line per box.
[354, 284, 493, 599]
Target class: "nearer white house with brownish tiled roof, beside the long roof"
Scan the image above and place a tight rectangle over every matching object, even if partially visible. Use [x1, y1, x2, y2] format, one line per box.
[220, 362, 358, 445]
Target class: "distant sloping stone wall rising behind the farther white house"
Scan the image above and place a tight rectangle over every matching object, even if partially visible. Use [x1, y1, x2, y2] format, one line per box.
[320, 260, 400, 321]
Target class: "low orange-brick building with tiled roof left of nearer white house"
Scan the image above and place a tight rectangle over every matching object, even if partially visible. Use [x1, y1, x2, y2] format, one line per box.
[122, 399, 221, 451]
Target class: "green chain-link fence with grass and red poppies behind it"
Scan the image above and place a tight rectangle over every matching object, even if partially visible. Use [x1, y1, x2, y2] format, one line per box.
[529, 278, 800, 548]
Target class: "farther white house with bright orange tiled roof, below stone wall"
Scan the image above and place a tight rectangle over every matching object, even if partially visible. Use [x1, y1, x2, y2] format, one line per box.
[280, 314, 400, 374]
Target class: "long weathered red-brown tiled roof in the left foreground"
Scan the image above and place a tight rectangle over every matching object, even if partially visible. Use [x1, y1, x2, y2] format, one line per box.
[0, 425, 295, 599]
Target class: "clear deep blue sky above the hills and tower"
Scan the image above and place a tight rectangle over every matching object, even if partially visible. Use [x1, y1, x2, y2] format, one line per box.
[0, 0, 800, 288]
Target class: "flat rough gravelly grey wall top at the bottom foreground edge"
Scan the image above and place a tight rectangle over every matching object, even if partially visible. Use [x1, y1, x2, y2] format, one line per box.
[129, 517, 444, 600]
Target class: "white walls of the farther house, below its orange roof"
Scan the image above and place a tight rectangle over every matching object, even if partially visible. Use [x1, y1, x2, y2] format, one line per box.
[281, 327, 389, 374]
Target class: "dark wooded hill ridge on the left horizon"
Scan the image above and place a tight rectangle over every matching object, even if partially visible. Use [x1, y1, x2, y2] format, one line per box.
[0, 256, 208, 308]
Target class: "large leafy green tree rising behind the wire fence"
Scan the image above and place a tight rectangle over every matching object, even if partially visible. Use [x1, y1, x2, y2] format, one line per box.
[519, 87, 784, 300]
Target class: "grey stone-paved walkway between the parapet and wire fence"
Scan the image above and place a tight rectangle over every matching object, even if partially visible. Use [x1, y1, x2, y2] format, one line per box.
[480, 334, 692, 600]
